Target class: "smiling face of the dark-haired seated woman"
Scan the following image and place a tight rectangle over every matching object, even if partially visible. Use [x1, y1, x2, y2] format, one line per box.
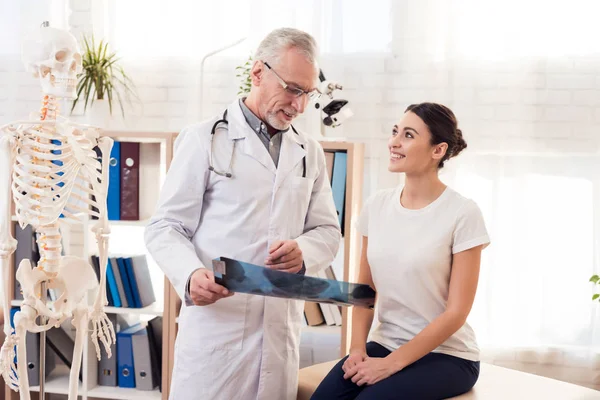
[388, 111, 448, 175]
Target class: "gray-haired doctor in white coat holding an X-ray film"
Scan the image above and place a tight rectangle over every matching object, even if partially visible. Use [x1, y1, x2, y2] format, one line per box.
[145, 29, 341, 400]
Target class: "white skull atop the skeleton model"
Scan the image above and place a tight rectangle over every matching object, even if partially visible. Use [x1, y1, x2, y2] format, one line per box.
[23, 27, 82, 99]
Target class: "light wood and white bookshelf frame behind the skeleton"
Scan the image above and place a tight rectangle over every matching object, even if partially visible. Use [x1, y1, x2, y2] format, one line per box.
[5, 131, 176, 400]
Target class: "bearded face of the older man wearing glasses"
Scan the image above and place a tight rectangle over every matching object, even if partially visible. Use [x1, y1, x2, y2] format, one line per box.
[252, 48, 318, 130]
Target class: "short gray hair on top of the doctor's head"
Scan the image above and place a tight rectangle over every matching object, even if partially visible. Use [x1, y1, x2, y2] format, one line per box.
[254, 28, 318, 67]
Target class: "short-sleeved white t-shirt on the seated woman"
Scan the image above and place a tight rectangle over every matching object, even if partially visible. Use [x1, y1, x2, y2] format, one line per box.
[358, 186, 490, 361]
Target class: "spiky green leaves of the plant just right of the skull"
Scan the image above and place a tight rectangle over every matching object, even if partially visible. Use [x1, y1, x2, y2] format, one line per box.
[71, 36, 137, 117]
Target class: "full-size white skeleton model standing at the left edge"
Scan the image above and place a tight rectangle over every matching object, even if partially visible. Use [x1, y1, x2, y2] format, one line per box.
[0, 24, 116, 400]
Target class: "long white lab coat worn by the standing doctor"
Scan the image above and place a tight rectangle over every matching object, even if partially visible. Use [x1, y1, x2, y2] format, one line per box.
[145, 100, 341, 400]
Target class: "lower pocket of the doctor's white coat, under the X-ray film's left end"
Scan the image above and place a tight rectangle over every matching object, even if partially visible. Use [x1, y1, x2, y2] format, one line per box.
[179, 293, 247, 350]
